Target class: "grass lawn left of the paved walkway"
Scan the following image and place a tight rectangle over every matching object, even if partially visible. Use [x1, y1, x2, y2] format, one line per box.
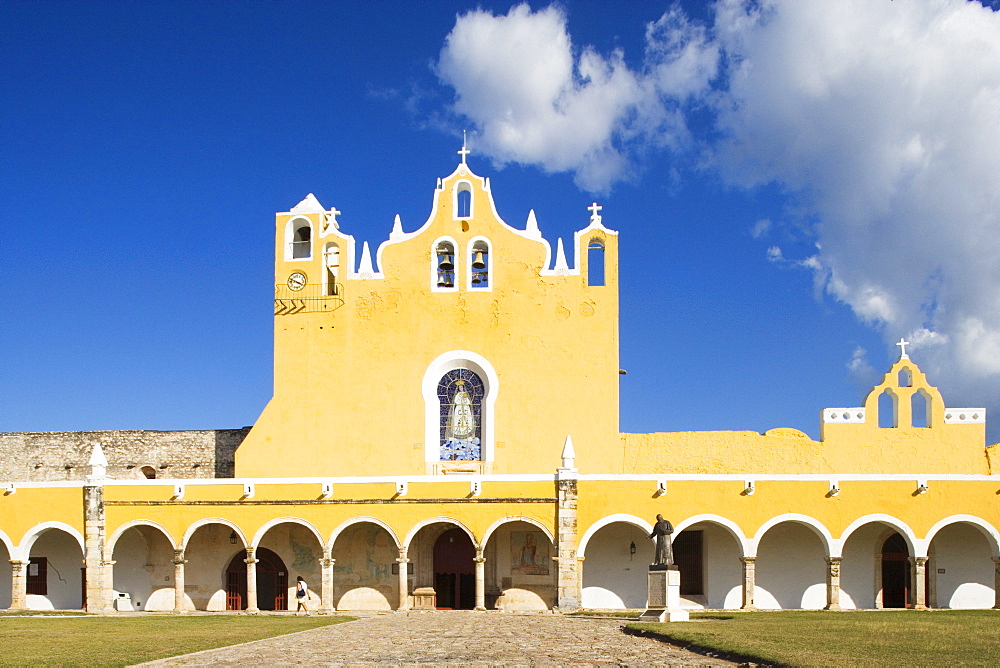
[0, 613, 351, 666]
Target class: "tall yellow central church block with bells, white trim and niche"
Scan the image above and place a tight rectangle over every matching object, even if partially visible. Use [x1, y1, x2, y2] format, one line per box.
[236, 146, 621, 476]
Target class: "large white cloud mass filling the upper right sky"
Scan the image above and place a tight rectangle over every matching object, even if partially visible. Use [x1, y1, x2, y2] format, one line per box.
[715, 0, 1000, 434]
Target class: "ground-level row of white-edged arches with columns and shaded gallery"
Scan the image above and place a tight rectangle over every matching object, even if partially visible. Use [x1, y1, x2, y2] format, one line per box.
[0, 517, 1000, 611]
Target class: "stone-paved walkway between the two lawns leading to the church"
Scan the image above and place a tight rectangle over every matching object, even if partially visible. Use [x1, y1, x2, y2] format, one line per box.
[135, 610, 734, 668]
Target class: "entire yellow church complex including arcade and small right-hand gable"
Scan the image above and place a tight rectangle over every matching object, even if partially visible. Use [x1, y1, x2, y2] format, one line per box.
[0, 149, 1000, 612]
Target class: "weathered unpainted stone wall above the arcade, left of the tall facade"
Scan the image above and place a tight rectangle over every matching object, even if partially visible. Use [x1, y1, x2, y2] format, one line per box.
[0, 427, 250, 482]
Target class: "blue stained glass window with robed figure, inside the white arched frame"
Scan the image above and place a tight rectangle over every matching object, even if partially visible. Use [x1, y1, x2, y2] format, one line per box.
[438, 369, 484, 461]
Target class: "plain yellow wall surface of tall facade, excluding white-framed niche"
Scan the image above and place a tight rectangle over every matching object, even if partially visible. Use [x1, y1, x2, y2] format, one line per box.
[236, 161, 620, 476]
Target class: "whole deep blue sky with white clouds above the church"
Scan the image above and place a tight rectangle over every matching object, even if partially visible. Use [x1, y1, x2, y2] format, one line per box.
[0, 5, 1000, 442]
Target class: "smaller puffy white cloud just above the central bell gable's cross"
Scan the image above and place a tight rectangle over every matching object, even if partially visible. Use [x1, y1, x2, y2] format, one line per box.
[437, 4, 718, 192]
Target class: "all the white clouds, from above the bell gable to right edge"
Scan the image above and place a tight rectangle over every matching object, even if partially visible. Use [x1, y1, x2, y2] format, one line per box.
[437, 0, 1000, 436]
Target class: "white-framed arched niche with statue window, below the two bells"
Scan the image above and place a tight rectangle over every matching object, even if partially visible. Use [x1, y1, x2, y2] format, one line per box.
[421, 350, 500, 475]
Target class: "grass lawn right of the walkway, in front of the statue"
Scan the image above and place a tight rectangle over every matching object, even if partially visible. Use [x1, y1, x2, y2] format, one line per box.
[627, 610, 1000, 666]
